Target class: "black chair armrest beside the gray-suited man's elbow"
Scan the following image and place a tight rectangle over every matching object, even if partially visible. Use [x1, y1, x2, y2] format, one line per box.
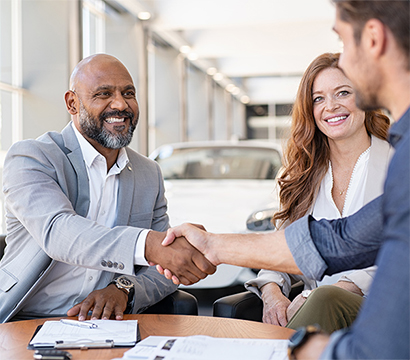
[142, 290, 198, 315]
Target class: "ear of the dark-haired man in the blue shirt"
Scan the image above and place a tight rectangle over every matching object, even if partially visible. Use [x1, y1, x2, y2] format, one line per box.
[362, 19, 387, 58]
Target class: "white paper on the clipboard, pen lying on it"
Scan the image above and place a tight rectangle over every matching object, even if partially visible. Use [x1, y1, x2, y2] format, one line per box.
[30, 320, 138, 347]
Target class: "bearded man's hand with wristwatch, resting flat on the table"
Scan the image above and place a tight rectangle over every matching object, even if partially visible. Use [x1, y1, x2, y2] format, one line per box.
[67, 284, 128, 321]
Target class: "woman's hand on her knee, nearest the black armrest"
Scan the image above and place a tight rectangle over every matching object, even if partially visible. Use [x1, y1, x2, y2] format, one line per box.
[261, 283, 291, 326]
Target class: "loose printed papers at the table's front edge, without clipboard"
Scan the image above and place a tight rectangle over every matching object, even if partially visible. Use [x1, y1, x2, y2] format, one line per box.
[113, 335, 289, 360]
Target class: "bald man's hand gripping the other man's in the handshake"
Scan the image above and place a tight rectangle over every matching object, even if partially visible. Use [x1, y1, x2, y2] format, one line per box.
[145, 226, 216, 285]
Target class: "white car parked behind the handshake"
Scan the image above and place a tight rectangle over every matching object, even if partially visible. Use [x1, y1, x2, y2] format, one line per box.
[150, 140, 282, 289]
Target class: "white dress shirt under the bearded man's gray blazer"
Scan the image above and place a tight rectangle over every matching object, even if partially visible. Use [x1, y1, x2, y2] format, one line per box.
[22, 125, 148, 315]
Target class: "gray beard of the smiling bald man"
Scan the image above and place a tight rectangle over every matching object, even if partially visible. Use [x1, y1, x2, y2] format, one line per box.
[78, 101, 136, 149]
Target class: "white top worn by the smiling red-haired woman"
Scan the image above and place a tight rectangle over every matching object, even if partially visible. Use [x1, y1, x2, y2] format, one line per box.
[245, 136, 394, 296]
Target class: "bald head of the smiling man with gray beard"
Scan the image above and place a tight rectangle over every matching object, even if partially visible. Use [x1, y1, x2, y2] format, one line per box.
[65, 54, 139, 153]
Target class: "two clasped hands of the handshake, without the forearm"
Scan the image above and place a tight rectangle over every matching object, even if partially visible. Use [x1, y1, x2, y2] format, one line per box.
[145, 224, 220, 285]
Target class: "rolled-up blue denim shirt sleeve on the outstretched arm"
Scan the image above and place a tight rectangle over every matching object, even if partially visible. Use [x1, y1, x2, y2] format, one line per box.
[285, 196, 383, 280]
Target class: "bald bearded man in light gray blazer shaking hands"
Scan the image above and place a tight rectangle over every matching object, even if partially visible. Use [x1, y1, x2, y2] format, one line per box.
[0, 54, 215, 322]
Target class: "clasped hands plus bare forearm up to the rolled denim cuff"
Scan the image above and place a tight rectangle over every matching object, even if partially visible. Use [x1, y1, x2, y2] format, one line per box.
[145, 224, 296, 285]
